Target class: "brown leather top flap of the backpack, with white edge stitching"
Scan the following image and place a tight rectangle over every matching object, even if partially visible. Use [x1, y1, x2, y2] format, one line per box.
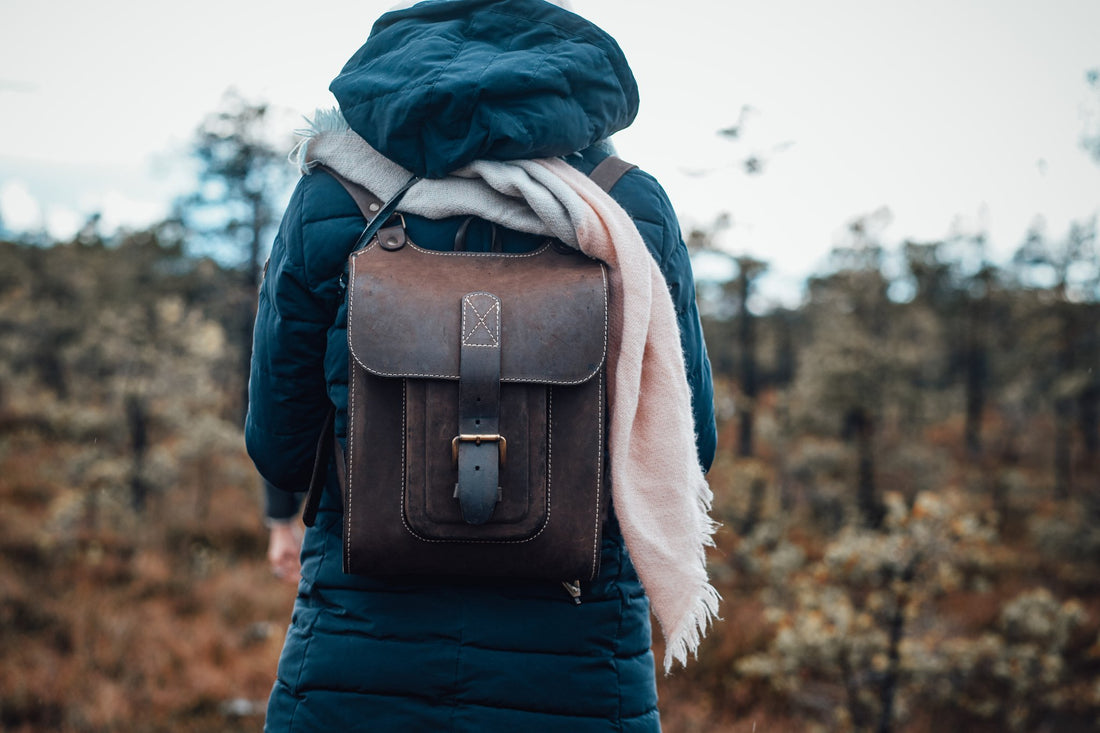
[348, 244, 608, 385]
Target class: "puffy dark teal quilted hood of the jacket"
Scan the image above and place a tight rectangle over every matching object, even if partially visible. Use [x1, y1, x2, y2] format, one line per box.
[329, 0, 638, 178]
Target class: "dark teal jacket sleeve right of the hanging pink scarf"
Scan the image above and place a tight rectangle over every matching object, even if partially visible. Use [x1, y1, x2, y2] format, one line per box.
[612, 169, 717, 470]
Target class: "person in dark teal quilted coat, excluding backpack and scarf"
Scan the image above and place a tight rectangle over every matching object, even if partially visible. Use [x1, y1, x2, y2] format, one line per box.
[245, 0, 716, 732]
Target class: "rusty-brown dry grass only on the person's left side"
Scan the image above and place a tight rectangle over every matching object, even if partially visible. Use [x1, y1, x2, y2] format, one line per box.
[0, 424, 294, 731]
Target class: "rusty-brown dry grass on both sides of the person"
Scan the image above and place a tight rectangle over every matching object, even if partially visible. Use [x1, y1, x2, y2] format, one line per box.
[0, 378, 1100, 733]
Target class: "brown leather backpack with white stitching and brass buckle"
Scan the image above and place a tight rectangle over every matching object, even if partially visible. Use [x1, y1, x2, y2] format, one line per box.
[307, 157, 634, 580]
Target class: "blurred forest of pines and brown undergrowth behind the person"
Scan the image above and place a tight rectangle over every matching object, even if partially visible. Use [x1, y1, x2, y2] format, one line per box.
[0, 74, 1100, 733]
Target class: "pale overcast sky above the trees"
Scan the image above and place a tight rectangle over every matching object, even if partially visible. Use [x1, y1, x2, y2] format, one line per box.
[0, 0, 1100, 295]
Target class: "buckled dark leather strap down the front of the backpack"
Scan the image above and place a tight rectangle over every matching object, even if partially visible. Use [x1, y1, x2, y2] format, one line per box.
[452, 293, 507, 524]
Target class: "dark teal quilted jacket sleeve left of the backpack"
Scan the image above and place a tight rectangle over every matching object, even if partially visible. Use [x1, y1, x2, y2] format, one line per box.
[244, 178, 332, 493]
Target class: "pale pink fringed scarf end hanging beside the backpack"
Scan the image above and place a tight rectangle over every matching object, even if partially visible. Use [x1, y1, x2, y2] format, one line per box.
[538, 160, 718, 672]
